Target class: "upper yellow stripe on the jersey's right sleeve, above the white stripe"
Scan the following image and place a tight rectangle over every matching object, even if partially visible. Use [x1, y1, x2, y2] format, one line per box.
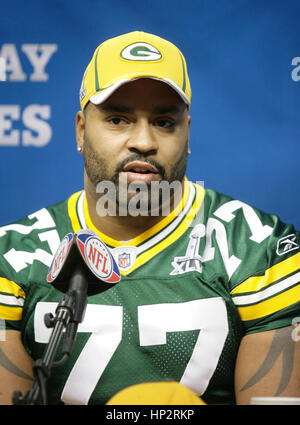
[231, 252, 300, 295]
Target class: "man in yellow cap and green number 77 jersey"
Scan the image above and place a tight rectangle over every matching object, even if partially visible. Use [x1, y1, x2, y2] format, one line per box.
[0, 32, 300, 404]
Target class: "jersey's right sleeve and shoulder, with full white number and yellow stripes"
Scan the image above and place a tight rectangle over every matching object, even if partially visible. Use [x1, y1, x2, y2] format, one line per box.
[204, 189, 300, 334]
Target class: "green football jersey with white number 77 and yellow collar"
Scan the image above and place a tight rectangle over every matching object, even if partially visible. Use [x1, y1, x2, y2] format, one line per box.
[0, 181, 300, 404]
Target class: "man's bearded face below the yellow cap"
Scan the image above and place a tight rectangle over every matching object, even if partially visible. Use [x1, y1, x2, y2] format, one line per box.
[76, 78, 190, 212]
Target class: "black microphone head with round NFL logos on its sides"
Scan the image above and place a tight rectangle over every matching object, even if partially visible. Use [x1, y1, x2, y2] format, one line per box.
[47, 229, 121, 295]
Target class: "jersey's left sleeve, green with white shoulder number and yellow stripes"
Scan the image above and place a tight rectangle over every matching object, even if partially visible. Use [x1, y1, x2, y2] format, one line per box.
[0, 209, 59, 330]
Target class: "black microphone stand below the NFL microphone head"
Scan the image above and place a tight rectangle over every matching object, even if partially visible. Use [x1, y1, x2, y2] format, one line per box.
[13, 267, 87, 405]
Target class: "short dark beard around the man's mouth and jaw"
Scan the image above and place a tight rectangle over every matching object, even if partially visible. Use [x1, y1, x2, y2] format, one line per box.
[83, 135, 188, 216]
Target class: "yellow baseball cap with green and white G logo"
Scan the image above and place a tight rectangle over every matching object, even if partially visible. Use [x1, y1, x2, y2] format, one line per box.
[79, 31, 192, 110]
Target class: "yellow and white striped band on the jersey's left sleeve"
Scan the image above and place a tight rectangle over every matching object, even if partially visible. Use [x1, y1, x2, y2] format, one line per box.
[0, 277, 25, 320]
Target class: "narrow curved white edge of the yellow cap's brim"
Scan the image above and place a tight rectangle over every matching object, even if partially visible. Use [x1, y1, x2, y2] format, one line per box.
[89, 75, 191, 106]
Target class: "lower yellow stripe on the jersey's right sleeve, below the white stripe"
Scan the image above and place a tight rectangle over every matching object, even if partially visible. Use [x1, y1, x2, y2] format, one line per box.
[238, 285, 300, 321]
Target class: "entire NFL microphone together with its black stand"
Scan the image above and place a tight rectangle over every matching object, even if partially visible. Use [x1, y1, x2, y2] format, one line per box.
[13, 229, 121, 405]
